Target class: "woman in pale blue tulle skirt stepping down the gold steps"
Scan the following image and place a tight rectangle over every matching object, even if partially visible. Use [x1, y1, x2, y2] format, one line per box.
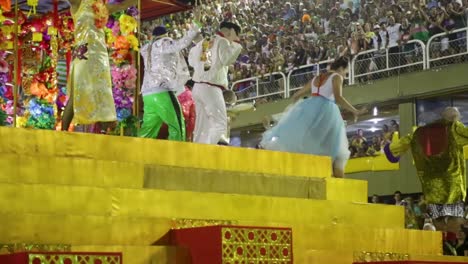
[260, 57, 366, 178]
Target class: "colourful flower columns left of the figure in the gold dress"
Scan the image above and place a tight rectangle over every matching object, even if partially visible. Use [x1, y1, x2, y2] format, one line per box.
[0, 4, 73, 129]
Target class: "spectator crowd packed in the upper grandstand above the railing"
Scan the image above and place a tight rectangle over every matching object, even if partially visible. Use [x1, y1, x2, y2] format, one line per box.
[143, 0, 468, 81]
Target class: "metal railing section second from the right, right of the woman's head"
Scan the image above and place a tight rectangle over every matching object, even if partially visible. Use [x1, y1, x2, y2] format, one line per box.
[351, 40, 426, 84]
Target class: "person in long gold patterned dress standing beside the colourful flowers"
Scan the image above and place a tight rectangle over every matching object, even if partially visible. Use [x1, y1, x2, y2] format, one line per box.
[62, 0, 117, 130]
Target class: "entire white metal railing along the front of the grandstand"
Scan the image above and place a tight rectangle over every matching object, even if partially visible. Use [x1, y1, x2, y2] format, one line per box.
[231, 27, 468, 102]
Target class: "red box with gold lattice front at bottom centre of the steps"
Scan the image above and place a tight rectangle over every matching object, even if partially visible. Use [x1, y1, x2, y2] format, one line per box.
[172, 226, 293, 264]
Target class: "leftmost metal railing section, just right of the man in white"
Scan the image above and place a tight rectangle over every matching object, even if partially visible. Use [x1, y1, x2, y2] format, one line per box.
[231, 72, 288, 102]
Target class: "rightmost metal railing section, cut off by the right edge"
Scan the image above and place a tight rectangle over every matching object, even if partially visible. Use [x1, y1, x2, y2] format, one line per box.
[426, 27, 468, 69]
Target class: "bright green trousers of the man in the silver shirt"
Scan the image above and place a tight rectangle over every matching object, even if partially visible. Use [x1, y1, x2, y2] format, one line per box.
[138, 92, 185, 141]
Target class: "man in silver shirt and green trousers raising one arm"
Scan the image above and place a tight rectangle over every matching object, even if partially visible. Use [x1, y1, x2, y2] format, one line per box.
[139, 15, 201, 141]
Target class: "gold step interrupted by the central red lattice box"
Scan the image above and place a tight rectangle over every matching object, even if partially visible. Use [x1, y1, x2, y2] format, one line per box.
[0, 213, 442, 263]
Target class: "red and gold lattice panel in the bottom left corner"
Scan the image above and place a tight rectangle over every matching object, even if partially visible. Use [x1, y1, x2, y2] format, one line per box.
[0, 252, 122, 264]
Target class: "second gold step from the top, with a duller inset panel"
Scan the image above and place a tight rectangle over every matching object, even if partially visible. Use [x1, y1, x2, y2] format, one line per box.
[0, 154, 367, 203]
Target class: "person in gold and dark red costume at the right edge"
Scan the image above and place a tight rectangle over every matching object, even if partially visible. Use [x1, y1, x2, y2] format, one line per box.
[384, 107, 468, 218]
